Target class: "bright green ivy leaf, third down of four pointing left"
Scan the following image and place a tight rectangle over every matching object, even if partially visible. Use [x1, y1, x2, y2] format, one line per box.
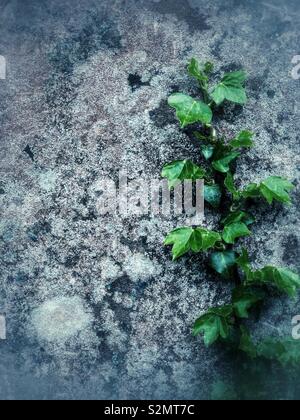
[165, 227, 221, 260]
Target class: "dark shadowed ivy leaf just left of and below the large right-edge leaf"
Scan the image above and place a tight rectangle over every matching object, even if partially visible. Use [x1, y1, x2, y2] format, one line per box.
[232, 286, 265, 318]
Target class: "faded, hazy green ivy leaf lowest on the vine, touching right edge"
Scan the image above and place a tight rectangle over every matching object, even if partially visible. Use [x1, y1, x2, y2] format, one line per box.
[257, 338, 300, 368]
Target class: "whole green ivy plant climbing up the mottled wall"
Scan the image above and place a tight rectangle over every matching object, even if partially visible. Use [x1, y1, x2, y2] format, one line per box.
[162, 58, 300, 365]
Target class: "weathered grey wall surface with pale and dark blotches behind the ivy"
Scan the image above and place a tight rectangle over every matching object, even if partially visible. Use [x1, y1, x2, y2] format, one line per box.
[0, 0, 300, 399]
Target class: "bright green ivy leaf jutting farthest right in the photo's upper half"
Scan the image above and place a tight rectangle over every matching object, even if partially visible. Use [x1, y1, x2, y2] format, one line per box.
[260, 176, 294, 204]
